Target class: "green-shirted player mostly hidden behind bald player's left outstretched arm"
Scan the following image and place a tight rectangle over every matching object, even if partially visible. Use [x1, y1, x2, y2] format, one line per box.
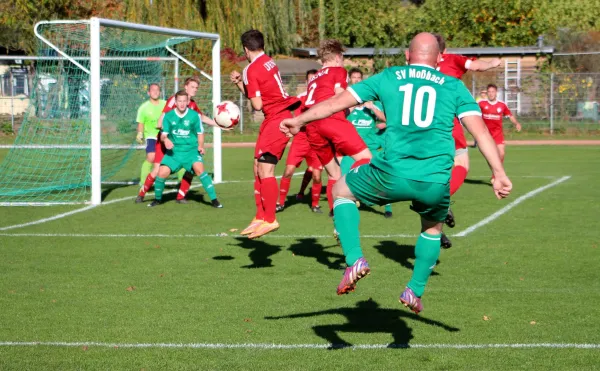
[340, 68, 393, 218]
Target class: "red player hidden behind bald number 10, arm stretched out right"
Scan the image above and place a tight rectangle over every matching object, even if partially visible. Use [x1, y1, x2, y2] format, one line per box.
[435, 34, 502, 249]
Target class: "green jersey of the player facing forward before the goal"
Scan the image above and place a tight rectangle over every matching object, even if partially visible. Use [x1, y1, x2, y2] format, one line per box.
[163, 108, 204, 153]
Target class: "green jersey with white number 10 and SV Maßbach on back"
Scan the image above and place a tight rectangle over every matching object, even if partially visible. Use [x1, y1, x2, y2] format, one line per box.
[348, 64, 481, 184]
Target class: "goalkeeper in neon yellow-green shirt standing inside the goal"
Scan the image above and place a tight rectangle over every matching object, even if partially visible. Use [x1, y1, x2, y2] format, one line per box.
[136, 83, 166, 186]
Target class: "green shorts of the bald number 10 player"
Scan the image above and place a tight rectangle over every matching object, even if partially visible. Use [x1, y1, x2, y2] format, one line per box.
[346, 164, 450, 222]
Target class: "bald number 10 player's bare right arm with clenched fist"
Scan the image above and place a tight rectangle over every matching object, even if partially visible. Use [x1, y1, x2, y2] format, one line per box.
[461, 115, 512, 199]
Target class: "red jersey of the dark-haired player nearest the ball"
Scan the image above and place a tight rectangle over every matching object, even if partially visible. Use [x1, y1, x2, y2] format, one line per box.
[243, 53, 298, 120]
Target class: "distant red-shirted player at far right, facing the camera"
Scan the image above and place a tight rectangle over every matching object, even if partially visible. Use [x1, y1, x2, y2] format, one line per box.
[479, 84, 521, 183]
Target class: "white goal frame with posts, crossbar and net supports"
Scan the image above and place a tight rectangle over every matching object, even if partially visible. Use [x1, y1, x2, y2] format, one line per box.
[34, 17, 223, 205]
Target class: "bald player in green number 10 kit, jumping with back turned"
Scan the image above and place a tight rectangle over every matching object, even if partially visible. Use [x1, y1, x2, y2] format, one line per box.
[280, 33, 512, 313]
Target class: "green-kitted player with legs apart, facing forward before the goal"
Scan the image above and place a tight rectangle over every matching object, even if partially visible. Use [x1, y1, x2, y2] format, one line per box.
[148, 90, 223, 208]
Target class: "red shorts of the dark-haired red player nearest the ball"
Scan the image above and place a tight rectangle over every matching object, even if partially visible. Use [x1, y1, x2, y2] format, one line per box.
[254, 110, 293, 160]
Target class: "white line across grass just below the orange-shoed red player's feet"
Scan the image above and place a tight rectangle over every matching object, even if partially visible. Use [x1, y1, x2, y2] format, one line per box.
[0, 233, 417, 238]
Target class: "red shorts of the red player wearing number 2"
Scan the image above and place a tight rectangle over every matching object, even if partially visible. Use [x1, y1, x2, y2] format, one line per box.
[306, 118, 367, 165]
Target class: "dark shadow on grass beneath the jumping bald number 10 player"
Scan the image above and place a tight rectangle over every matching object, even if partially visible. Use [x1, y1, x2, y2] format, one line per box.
[265, 299, 460, 349]
